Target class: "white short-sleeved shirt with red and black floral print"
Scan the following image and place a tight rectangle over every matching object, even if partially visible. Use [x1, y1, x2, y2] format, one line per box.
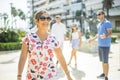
[23, 33, 59, 80]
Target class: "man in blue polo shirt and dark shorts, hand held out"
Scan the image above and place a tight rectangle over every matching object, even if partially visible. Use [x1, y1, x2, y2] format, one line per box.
[88, 10, 112, 80]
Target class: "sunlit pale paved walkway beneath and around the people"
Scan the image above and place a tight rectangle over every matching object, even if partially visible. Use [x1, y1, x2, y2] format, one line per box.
[0, 41, 120, 80]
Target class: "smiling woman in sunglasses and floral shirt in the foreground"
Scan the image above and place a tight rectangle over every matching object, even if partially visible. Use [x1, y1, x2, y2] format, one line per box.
[17, 10, 72, 80]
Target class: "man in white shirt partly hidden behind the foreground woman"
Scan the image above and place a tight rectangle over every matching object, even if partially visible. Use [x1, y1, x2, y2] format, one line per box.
[51, 15, 66, 65]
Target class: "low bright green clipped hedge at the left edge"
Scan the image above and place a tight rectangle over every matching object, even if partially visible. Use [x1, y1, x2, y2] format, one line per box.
[0, 42, 21, 51]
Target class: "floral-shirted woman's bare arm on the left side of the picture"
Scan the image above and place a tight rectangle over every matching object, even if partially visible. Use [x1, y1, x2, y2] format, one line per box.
[17, 42, 28, 80]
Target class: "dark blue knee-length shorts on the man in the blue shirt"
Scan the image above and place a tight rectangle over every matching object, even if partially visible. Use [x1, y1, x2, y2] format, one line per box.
[98, 47, 110, 63]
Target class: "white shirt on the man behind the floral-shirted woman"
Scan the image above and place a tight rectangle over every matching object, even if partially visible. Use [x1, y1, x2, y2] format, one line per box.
[51, 23, 66, 43]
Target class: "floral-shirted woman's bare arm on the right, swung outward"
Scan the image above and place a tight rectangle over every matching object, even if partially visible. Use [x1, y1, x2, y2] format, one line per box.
[54, 48, 72, 80]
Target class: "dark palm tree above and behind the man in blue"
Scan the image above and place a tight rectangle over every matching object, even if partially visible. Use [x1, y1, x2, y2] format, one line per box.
[102, 0, 114, 18]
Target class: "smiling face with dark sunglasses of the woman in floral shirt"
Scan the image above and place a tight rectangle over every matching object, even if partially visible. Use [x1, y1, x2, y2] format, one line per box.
[37, 13, 51, 28]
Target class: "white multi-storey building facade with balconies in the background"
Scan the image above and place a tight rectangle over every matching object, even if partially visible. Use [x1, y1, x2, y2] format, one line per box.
[28, 0, 120, 30]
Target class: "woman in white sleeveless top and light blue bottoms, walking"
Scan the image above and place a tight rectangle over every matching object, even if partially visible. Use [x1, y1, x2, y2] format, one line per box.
[68, 23, 82, 67]
